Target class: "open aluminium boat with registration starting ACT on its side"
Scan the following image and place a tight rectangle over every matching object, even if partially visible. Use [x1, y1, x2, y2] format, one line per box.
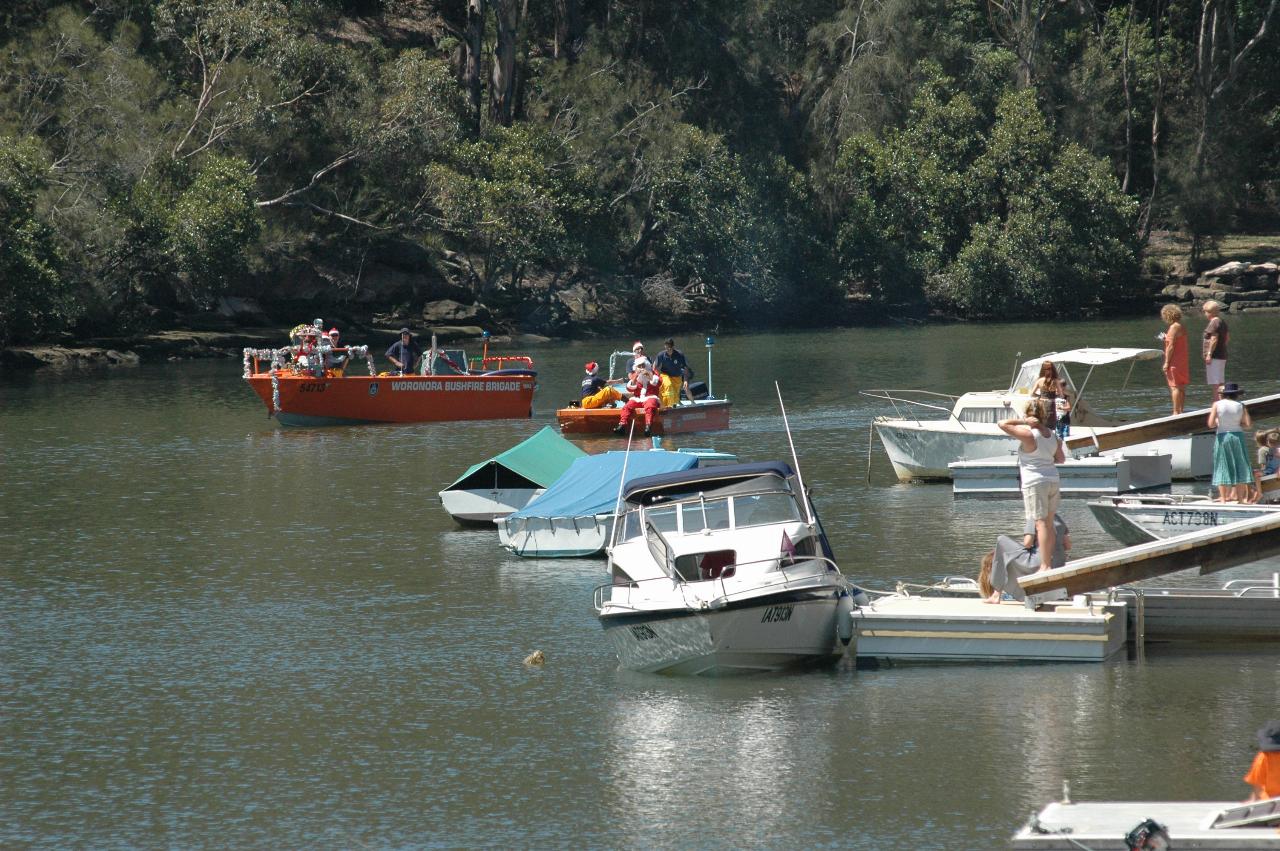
[1088, 494, 1280, 545]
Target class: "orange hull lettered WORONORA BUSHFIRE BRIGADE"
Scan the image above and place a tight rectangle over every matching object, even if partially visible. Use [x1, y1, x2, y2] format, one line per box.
[247, 372, 536, 426]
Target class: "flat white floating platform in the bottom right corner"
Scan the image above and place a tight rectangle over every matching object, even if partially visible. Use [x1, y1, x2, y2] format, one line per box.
[1011, 799, 1280, 851]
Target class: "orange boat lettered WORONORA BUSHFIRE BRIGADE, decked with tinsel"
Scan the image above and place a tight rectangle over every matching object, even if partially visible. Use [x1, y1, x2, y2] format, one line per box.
[244, 332, 538, 426]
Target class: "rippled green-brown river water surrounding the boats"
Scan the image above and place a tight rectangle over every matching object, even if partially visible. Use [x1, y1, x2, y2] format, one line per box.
[0, 316, 1280, 848]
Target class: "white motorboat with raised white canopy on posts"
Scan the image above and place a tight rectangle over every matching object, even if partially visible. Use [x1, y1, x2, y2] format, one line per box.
[863, 348, 1213, 481]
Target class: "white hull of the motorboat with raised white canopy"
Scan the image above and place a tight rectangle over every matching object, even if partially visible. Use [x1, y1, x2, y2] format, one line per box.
[876, 418, 1213, 481]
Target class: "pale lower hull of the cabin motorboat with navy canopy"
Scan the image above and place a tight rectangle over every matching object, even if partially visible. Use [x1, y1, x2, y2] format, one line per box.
[599, 590, 844, 676]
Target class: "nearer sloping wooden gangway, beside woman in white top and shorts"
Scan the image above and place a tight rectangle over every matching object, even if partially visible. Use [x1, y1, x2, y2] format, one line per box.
[1018, 506, 1280, 607]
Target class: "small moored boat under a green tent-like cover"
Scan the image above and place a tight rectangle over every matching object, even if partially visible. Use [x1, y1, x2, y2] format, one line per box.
[440, 426, 586, 527]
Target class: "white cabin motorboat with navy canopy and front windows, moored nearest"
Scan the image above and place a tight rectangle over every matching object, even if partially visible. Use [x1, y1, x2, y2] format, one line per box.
[594, 462, 860, 674]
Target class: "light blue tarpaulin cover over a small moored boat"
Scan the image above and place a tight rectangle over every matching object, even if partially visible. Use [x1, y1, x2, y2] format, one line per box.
[507, 450, 698, 522]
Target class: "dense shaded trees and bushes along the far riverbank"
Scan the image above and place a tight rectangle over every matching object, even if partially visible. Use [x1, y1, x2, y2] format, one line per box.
[0, 0, 1280, 344]
